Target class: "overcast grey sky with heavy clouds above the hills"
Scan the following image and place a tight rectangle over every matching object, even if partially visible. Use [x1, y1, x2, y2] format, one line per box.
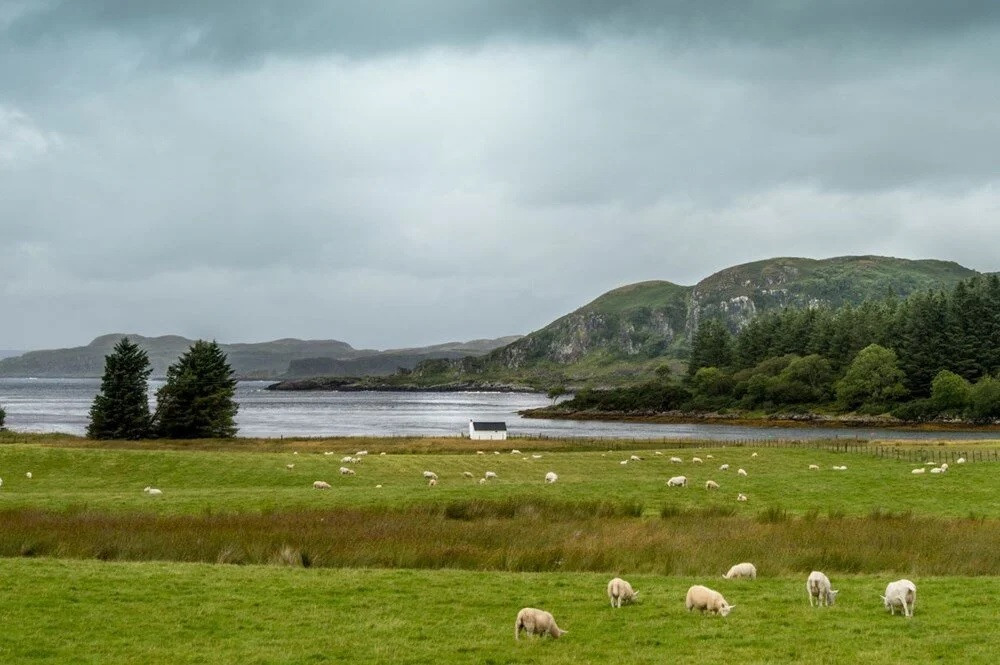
[0, 0, 1000, 349]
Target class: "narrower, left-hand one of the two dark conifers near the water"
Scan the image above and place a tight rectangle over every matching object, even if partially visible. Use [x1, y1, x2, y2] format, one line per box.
[87, 337, 153, 439]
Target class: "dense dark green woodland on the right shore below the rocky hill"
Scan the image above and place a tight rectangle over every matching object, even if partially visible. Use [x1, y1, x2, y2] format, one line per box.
[562, 275, 1000, 422]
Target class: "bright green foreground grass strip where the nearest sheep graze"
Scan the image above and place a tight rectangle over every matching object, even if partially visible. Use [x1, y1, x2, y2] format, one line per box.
[0, 559, 1000, 665]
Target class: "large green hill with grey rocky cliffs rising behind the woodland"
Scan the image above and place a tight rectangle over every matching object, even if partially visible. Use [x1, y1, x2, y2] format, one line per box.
[410, 256, 978, 386]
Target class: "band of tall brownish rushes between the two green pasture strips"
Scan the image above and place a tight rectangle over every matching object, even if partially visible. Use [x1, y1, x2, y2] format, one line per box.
[0, 502, 1000, 575]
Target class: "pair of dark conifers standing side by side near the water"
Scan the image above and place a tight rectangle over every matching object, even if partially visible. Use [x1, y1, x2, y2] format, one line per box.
[87, 337, 238, 439]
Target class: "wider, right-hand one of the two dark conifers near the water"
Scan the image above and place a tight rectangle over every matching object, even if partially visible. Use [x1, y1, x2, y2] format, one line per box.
[154, 340, 238, 439]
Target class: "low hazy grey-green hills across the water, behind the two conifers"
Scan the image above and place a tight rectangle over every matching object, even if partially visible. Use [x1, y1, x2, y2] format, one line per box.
[0, 333, 517, 379]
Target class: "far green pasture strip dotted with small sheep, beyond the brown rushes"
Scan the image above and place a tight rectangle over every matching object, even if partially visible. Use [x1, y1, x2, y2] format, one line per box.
[0, 439, 1000, 519]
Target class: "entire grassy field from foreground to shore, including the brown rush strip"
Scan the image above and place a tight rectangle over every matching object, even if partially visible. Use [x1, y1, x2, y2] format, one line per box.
[0, 435, 1000, 664]
